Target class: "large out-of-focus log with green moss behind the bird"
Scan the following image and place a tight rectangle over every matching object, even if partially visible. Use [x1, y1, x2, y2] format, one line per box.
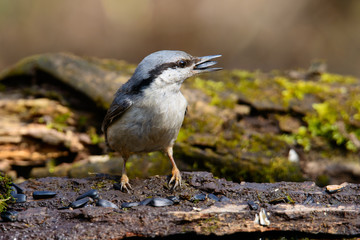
[0, 53, 360, 184]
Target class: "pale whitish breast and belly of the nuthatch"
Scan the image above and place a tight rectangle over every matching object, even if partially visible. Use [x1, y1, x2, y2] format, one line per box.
[108, 92, 187, 152]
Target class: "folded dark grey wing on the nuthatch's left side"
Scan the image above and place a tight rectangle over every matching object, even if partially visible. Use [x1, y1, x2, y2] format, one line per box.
[101, 96, 133, 143]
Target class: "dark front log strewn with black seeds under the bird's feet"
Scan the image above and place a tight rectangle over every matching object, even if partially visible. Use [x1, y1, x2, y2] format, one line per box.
[0, 172, 360, 239]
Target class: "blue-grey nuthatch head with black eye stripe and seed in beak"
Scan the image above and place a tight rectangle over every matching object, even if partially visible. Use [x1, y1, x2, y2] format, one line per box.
[128, 50, 222, 92]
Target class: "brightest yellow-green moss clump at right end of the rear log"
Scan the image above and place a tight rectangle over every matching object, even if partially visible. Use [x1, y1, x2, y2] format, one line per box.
[274, 73, 360, 151]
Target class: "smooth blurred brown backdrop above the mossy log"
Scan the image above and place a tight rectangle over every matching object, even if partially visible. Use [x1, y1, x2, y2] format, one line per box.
[0, 0, 360, 76]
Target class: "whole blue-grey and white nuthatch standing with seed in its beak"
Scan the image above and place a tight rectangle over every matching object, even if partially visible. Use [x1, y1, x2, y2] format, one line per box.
[102, 50, 221, 191]
